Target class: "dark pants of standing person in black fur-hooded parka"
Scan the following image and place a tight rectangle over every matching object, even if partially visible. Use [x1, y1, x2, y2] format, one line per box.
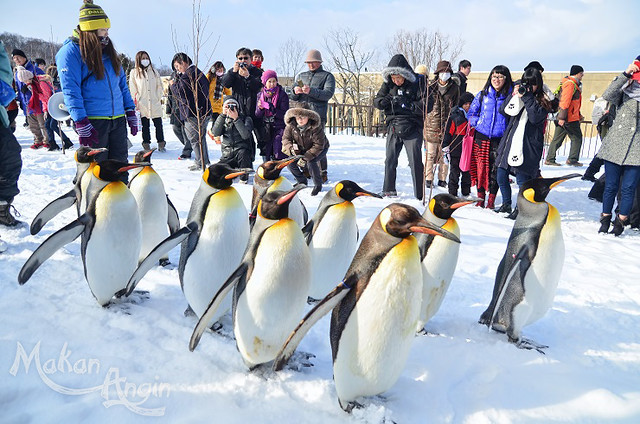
[382, 125, 424, 200]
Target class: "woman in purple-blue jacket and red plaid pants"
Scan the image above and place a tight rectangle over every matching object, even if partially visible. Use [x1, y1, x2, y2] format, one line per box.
[467, 65, 513, 209]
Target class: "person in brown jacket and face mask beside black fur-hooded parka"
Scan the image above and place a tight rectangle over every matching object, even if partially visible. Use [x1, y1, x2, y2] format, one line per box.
[423, 60, 460, 188]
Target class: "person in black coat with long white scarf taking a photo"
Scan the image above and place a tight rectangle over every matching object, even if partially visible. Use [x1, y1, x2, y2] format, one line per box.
[493, 68, 551, 218]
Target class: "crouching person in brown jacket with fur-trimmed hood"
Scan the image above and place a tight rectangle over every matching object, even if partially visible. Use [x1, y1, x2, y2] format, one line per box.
[282, 108, 329, 196]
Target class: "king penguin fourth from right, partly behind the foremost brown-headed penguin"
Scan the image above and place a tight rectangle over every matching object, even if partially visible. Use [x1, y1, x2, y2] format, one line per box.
[302, 180, 381, 301]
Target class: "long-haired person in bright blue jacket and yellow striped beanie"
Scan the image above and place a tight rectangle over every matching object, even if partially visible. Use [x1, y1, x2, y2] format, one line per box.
[56, 0, 138, 161]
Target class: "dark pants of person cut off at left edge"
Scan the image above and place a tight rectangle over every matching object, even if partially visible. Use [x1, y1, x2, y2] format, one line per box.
[0, 123, 22, 203]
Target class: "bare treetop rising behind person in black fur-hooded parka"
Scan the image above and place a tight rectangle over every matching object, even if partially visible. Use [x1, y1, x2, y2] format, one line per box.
[387, 28, 464, 70]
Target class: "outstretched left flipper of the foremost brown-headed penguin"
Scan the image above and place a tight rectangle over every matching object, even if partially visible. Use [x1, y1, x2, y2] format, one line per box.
[273, 283, 351, 371]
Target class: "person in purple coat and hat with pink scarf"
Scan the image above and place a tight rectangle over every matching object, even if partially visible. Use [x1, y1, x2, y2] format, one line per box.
[256, 70, 289, 162]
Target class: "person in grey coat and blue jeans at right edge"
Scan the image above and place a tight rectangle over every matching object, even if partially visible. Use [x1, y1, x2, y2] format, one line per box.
[598, 55, 640, 236]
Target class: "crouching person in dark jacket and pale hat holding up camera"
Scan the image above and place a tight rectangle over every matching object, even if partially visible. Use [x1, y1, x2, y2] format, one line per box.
[213, 97, 253, 182]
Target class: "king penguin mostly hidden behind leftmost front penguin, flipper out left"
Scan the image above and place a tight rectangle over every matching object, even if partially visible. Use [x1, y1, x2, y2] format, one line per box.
[30, 146, 107, 235]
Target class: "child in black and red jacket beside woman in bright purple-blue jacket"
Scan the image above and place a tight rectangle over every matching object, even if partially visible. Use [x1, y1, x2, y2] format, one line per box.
[442, 93, 473, 196]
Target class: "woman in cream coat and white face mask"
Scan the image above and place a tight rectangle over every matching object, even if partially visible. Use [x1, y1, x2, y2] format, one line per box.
[129, 50, 166, 152]
